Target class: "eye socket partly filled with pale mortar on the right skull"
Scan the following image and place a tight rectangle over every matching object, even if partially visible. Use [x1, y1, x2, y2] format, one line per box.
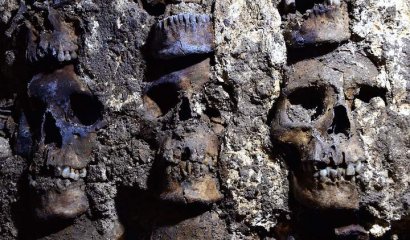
[288, 87, 326, 121]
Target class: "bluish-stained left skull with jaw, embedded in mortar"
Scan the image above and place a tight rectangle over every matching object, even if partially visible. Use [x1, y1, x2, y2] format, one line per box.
[23, 65, 102, 219]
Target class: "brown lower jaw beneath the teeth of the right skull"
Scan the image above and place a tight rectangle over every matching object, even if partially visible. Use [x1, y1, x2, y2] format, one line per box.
[292, 172, 360, 210]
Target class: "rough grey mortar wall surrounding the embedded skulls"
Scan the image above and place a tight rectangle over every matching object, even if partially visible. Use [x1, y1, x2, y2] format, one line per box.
[0, 0, 410, 240]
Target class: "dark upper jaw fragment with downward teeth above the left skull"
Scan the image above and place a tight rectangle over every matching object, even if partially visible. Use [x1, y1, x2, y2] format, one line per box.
[26, 7, 78, 62]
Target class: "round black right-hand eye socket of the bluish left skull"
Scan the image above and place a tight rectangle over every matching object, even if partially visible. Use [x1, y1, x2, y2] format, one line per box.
[70, 93, 103, 126]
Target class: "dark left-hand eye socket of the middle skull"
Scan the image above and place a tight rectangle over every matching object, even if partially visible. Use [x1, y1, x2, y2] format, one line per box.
[146, 83, 179, 116]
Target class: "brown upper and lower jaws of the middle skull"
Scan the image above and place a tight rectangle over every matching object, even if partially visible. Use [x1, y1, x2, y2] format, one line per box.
[157, 125, 222, 204]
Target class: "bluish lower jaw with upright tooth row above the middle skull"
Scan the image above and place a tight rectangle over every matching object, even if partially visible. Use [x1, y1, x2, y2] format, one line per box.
[150, 13, 214, 59]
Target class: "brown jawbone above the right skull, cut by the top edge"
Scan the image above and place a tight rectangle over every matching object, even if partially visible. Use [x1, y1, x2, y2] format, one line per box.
[283, 0, 350, 47]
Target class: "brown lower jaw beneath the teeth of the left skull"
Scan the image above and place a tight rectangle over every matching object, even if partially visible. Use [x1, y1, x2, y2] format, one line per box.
[35, 186, 89, 220]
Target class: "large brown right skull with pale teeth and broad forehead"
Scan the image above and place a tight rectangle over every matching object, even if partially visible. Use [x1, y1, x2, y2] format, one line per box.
[271, 50, 377, 209]
